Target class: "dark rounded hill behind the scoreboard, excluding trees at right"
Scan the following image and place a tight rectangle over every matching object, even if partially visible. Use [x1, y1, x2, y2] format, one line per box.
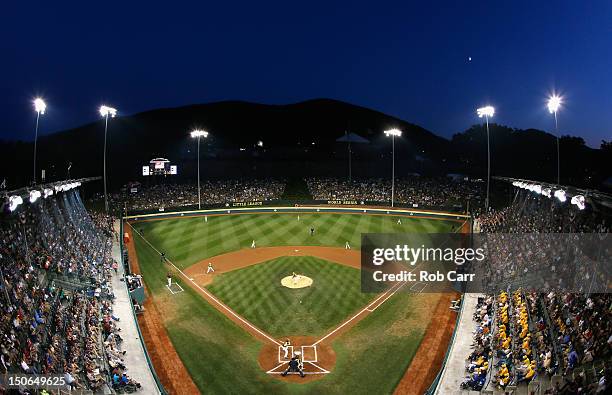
[0, 99, 451, 187]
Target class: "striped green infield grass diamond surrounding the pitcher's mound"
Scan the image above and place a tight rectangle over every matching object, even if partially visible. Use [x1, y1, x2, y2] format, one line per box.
[208, 256, 372, 338]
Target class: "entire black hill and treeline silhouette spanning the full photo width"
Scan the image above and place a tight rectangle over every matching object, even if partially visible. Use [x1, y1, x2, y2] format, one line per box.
[0, 99, 612, 189]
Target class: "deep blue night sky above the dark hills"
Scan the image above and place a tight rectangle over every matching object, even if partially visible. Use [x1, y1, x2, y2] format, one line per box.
[0, 0, 612, 147]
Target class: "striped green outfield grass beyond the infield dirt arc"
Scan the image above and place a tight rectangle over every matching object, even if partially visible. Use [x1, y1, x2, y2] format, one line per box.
[135, 214, 457, 269]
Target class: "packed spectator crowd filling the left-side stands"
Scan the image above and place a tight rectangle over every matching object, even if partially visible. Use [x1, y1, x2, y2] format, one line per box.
[0, 190, 140, 391]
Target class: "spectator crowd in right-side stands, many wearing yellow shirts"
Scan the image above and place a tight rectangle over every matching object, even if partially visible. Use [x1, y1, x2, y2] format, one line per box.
[462, 191, 612, 394]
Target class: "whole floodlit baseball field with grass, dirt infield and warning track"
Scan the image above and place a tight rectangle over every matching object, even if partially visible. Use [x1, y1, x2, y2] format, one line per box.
[125, 213, 461, 394]
